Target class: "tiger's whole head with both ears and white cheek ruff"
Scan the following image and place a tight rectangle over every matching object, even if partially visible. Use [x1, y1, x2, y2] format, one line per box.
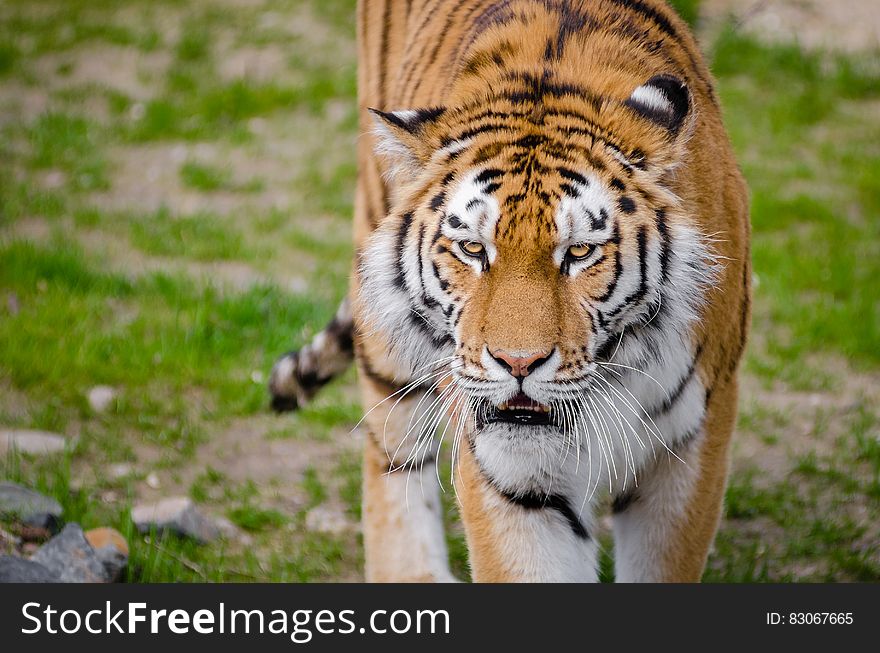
[358, 75, 712, 468]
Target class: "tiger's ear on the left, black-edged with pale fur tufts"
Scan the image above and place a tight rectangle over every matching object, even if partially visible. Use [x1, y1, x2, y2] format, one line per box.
[369, 107, 445, 181]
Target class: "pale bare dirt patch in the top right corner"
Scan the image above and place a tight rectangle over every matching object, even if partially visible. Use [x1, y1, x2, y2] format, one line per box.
[701, 0, 880, 52]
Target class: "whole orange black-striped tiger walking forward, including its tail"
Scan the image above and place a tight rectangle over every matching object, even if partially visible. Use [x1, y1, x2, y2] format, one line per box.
[269, 0, 751, 582]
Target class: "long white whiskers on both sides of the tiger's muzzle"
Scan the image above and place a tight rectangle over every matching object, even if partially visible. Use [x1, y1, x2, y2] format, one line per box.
[359, 356, 687, 510]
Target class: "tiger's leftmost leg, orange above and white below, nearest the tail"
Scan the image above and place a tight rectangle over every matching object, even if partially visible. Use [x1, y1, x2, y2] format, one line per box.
[358, 338, 455, 582]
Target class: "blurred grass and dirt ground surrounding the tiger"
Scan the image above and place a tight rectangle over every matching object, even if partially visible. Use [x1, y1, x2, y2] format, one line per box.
[0, 0, 880, 582]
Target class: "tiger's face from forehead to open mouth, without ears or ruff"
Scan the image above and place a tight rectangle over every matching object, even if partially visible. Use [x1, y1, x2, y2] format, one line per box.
[436, 158, 628, 428]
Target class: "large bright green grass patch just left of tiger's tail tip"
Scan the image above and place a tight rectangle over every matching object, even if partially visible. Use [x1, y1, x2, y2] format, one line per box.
[0, 241, 331, 428]
